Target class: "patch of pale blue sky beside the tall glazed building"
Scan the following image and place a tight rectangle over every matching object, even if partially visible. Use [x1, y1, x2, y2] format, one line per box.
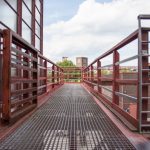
[44, 0, 112, 25]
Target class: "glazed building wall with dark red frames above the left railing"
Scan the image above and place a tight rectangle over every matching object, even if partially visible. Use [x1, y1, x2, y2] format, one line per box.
[0, 0, 43, 52]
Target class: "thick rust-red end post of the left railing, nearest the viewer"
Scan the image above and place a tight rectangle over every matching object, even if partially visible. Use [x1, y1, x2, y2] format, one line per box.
[2, 30, 12, 121]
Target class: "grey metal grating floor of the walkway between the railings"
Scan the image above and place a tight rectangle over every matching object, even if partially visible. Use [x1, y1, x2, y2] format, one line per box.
[0, 84, 135, 150]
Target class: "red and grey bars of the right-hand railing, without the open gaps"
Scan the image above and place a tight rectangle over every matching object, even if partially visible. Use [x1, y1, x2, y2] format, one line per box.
[82, 15, 150, 133]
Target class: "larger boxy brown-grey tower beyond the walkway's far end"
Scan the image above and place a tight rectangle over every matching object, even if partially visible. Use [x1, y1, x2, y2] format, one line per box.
[76, 57, 88, 67]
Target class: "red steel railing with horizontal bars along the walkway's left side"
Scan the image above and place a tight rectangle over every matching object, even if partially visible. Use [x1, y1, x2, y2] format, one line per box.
[0, 29, 63, 122]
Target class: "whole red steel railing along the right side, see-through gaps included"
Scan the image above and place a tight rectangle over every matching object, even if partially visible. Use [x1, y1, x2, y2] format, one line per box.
[83, 15, 150, 132]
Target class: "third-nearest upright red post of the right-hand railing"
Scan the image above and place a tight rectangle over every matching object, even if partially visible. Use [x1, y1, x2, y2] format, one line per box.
[97, 60, 102, 93]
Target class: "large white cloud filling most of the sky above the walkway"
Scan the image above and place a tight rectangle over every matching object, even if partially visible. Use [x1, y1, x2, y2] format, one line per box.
[44, 0, 150, 62]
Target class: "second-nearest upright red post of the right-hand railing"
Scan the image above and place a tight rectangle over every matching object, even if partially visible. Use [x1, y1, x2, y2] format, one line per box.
[112, 50, 119, 105]
